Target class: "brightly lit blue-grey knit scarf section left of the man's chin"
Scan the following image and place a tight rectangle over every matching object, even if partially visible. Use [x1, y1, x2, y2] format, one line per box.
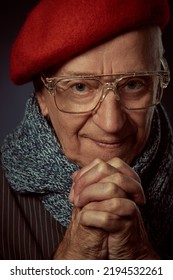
[2, 96, 79, 226]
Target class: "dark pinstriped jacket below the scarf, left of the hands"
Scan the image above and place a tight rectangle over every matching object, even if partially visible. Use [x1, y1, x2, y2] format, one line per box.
[0, 165, 65, 260]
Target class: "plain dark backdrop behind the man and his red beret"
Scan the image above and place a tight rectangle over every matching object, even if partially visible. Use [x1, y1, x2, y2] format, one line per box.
[0, 0, 173, 144]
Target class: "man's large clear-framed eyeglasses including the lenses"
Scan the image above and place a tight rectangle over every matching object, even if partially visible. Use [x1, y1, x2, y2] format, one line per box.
[41, 58, 170, 114]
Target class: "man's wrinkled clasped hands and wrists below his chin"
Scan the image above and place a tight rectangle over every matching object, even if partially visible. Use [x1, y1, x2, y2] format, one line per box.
[54, 158, 159, 260]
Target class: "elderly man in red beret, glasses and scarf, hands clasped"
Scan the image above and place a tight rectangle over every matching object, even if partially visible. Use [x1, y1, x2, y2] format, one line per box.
[1, 0, 173, 259]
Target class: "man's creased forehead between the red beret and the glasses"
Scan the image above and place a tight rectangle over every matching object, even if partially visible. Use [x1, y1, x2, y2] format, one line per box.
[56, 27, 163, 75]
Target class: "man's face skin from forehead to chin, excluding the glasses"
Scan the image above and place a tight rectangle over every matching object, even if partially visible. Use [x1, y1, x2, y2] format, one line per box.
[37, 27, 160, 167]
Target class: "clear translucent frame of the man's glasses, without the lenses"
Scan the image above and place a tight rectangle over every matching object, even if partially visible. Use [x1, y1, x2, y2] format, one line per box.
[41, 57, 170, 114]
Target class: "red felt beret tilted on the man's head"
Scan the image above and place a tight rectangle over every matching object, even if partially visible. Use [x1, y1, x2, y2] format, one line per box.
[10, 0, 169, 84]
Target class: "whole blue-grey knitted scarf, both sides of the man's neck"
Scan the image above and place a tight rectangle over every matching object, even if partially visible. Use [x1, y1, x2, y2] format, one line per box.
[1, 94, 173, 256]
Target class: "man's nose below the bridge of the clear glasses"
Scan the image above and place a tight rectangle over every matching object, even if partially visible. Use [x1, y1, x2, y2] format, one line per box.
[93, 88, 126, 133]
